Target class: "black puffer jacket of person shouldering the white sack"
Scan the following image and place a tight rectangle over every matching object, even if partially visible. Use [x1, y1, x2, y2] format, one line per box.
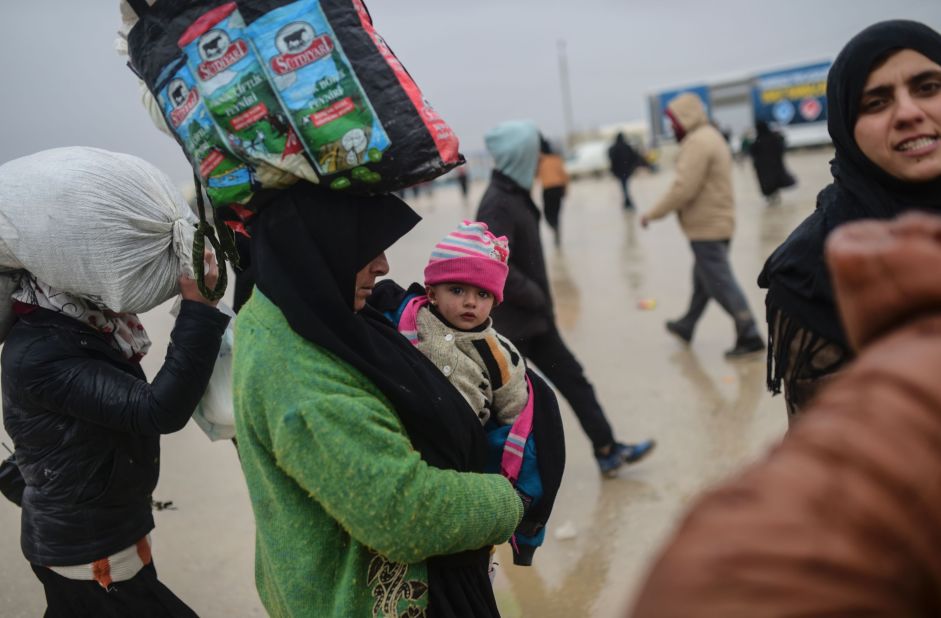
[0, 301, 228, 566]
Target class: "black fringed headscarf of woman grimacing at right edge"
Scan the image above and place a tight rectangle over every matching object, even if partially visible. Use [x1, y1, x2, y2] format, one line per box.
[758, 20, 941, 392]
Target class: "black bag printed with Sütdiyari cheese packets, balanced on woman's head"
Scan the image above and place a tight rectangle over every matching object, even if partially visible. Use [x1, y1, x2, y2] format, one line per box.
[122, 0, 463, 199]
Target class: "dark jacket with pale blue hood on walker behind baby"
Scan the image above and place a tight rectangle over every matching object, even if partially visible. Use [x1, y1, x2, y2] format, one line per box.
[476, 122, 555, 341]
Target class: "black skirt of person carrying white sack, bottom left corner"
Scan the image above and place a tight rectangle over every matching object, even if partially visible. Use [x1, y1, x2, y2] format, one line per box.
[31, 562, 198, 618]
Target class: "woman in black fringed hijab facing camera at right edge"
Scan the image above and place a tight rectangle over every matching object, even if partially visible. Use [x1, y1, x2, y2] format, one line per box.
[758, 20, 941, 420]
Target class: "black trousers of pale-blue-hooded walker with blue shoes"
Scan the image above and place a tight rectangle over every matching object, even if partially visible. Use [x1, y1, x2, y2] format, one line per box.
[512, 325, 614, 450]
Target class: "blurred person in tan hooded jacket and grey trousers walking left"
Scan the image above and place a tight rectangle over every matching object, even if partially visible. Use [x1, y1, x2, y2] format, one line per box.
[640, 93, 765, 358]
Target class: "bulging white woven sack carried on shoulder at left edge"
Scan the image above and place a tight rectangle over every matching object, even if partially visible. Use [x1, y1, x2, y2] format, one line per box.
[0, 147, 195, 322]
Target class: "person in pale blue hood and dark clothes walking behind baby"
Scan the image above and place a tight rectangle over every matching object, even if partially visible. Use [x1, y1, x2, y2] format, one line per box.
[477, 122, 654, 476]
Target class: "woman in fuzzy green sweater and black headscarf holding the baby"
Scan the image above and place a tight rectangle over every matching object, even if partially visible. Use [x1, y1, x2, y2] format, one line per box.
[234, 183, 523, 617]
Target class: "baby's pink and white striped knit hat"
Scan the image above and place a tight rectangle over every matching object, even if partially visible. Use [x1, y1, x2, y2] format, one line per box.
[425, 220, 510, 303]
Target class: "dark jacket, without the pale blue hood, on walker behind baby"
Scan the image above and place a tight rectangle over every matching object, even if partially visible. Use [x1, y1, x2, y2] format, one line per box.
[477, 171, 555, 342]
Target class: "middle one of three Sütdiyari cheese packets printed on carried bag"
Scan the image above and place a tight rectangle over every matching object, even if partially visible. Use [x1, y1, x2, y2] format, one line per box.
[178, 2, 318, 182]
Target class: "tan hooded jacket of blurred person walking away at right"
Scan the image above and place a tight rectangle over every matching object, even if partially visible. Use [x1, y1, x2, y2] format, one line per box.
[645, 92, 735, 240]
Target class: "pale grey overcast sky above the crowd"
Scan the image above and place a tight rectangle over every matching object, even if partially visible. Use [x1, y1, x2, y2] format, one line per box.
[0, 0, 941, 182]
